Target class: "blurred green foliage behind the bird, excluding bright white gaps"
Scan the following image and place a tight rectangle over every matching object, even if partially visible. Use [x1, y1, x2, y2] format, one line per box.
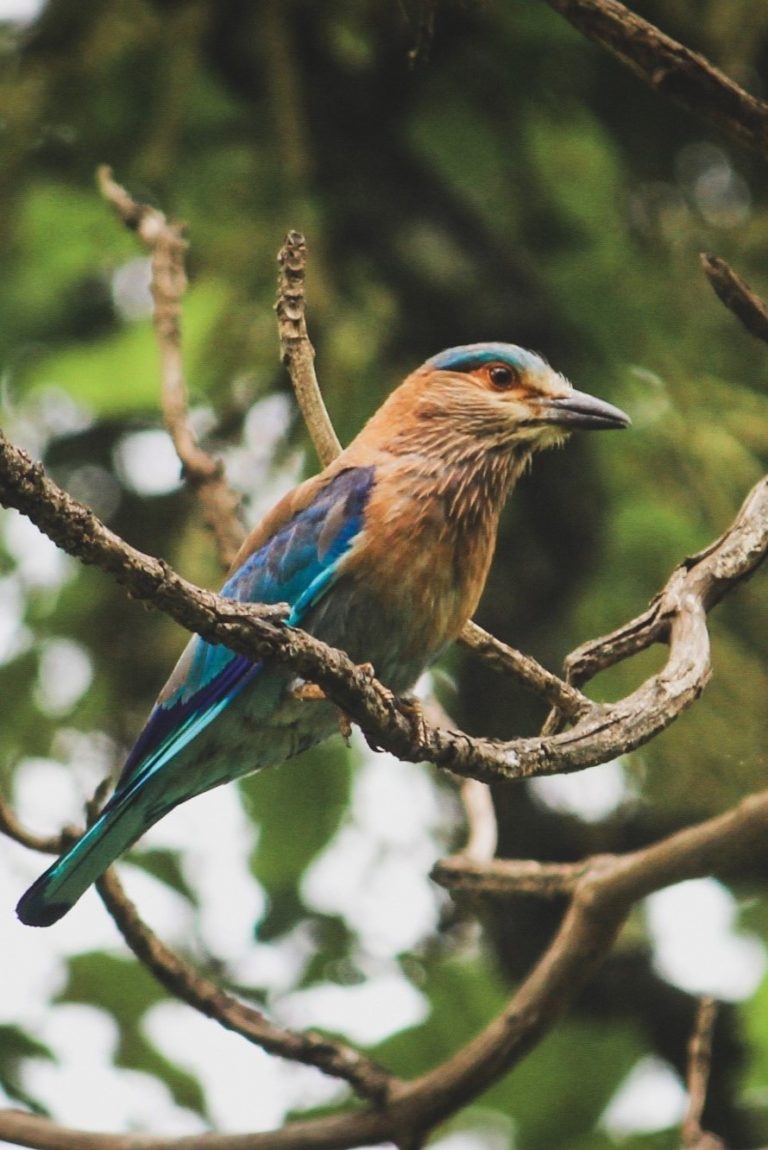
[0, 0, 768, 1150]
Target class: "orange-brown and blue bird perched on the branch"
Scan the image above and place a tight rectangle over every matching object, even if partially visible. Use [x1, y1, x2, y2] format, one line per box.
[17, 343, 630, 927]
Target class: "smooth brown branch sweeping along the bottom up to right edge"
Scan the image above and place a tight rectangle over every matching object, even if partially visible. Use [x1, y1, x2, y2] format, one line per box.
[0, 791, 768, 1150]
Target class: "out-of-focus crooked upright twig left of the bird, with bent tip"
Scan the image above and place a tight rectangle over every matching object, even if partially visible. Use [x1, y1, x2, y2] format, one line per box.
[97, 167, 243, 567]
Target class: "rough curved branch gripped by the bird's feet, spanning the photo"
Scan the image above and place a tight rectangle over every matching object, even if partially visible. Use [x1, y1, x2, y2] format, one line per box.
[0, 432, 768, 782]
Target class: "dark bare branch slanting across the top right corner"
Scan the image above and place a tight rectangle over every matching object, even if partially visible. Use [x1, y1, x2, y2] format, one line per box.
[546, 0, 768, 155]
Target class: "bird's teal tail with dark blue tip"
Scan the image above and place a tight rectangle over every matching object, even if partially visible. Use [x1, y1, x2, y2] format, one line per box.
[16, 787, 152, 927]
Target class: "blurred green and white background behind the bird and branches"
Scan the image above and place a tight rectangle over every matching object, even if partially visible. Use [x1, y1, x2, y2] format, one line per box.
[0, 0, 768, 1150]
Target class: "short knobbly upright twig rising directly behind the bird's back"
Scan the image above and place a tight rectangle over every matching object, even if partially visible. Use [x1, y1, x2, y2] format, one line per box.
[275, 231, 341, 467]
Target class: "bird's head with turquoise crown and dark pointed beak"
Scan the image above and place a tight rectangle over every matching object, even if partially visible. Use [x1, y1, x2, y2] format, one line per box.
[408, 343, 630, 451]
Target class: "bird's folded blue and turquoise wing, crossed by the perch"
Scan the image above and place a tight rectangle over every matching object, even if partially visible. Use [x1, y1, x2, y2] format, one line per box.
[116, 467, 374, 794]
